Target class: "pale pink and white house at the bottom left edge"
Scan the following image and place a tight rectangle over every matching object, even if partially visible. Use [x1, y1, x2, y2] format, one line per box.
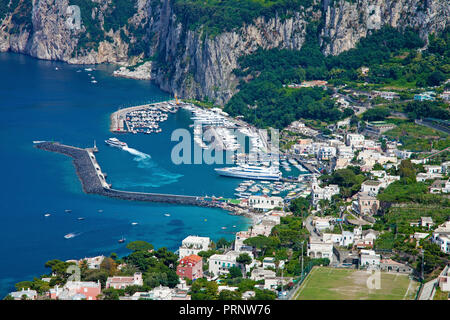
[50, 281, 102, 300]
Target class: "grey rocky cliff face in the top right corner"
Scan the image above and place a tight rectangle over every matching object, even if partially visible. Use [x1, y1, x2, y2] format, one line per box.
[321, 0, 450, 55]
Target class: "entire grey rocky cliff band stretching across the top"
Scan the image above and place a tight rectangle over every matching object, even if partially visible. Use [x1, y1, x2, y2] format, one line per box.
[0, 0, 450, 104]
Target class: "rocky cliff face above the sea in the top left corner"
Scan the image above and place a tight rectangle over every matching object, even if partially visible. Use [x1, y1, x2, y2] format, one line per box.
[0, 0, 147, 64]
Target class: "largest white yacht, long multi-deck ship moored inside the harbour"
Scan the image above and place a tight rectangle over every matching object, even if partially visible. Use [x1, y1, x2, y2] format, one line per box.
[214, 165, 281, 180]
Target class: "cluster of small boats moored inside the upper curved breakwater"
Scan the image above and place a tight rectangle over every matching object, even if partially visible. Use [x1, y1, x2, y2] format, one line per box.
[125, 102, 177, 134]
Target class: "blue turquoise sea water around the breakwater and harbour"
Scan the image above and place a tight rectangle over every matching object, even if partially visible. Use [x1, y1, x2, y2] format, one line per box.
[0, 53, 249, 298]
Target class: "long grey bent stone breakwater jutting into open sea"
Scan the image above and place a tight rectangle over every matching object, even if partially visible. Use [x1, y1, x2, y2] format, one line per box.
[35, 141, 220, 207]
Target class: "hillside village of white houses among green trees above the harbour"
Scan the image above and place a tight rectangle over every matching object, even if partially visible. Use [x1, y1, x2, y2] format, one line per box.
[6, 82, 450, 300]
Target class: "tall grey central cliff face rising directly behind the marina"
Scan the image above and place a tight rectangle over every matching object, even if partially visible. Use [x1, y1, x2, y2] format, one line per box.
[149, 2, 320, 104]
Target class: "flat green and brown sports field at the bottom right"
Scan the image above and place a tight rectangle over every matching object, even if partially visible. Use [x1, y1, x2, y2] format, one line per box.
[294, 267, 419, 300]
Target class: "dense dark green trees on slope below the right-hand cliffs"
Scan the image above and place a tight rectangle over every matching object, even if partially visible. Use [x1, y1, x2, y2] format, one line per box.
[225, 23, 450, 128]
